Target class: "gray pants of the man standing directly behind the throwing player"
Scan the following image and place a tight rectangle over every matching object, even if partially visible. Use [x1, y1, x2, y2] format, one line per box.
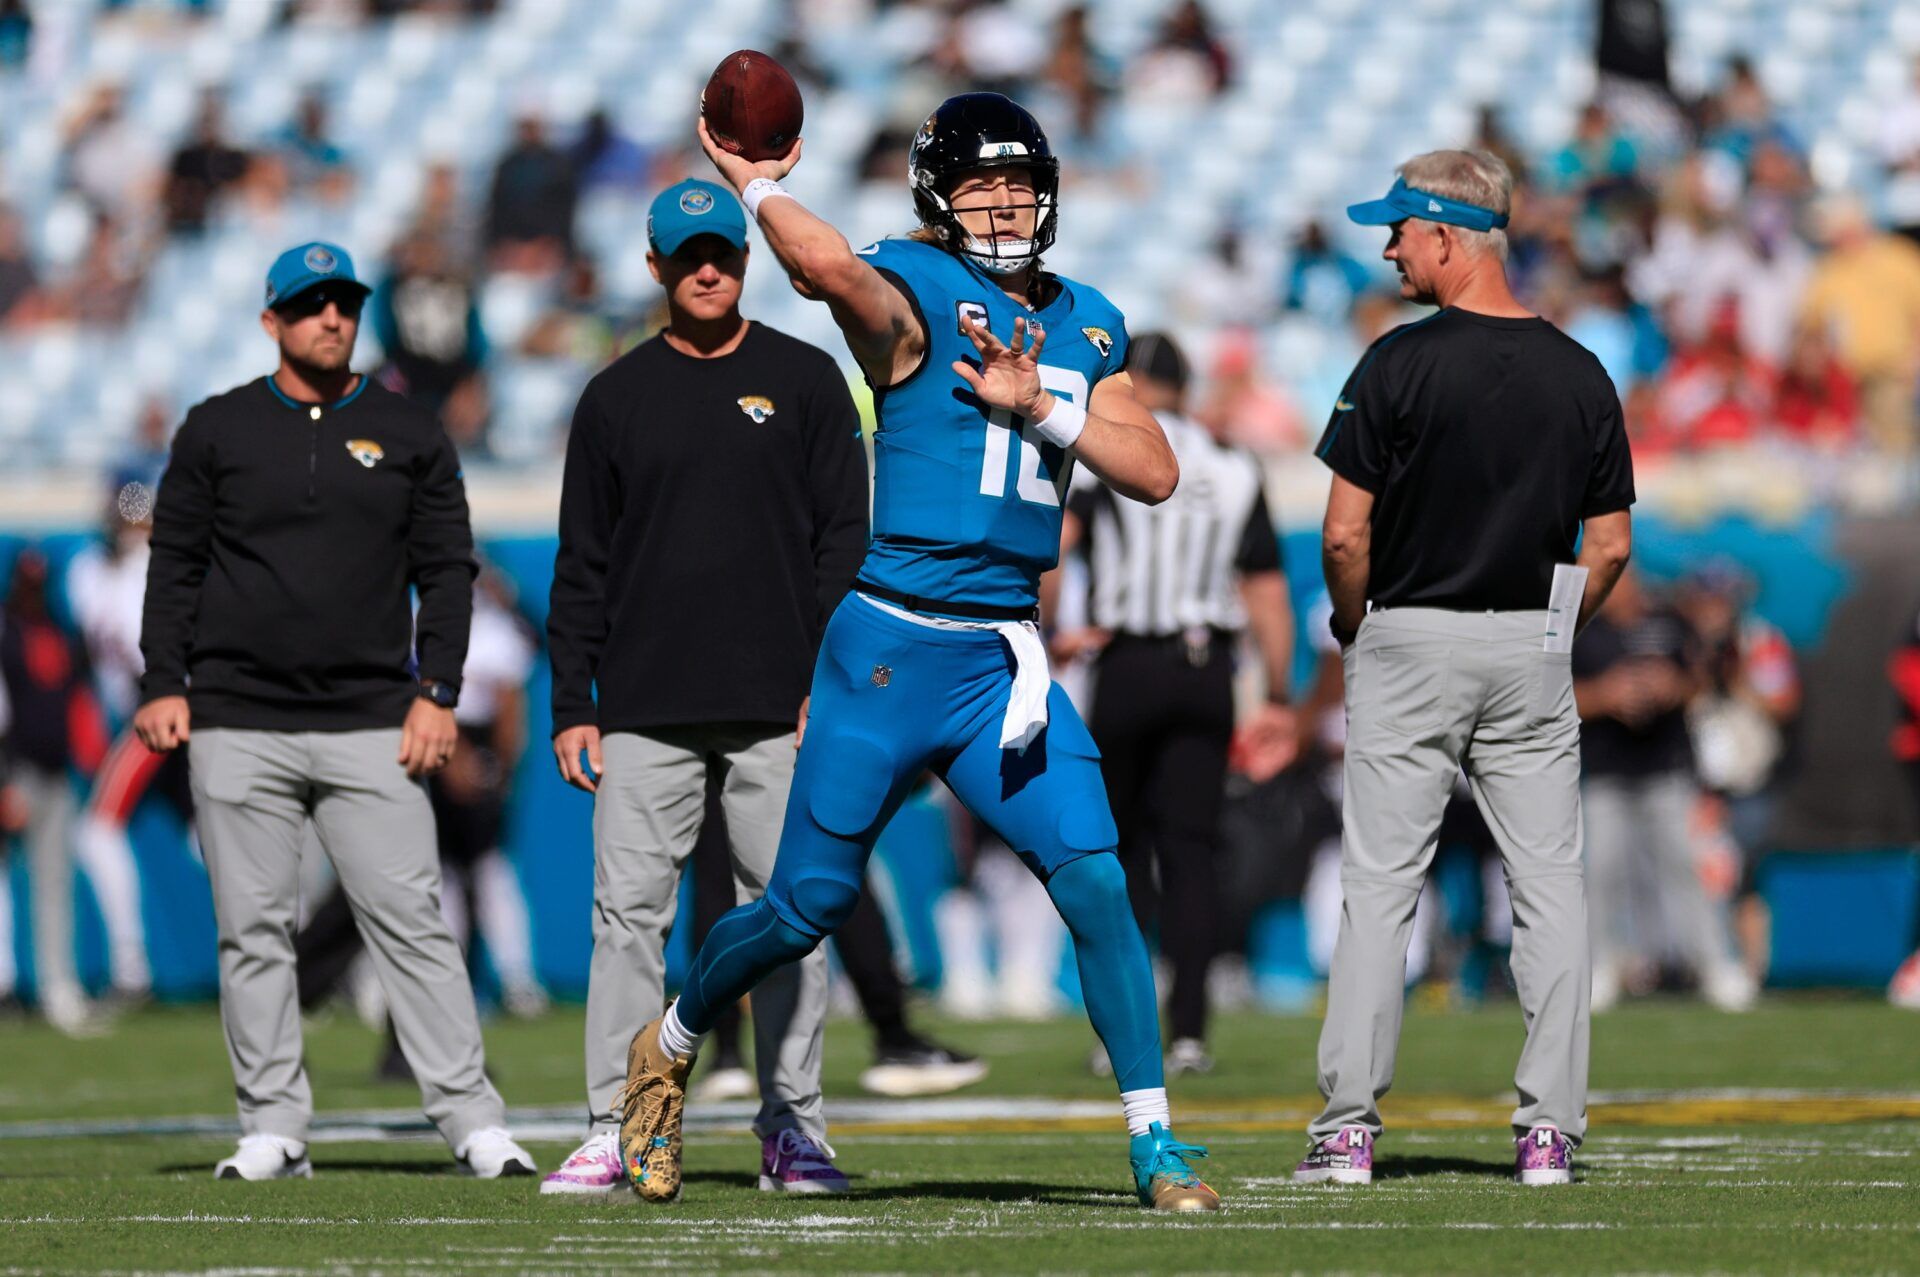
[588, 724, 828, 1141]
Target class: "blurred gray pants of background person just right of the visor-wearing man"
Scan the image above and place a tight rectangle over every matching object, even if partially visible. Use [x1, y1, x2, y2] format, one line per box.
[1582, 772, 1734, 979]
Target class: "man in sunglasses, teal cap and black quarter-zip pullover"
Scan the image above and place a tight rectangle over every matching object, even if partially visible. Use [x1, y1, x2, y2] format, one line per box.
[134, 244, 534, 1179]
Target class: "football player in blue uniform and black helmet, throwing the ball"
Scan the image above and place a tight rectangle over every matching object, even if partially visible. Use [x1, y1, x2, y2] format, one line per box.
[622, 94, 1219, 1210]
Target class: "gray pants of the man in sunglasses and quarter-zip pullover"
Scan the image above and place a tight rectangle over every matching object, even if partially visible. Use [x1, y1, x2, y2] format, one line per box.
[188, 728, 505, 1148]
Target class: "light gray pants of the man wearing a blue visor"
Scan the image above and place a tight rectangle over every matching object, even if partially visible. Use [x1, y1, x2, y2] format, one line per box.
[1308, 609, 1592, 1143]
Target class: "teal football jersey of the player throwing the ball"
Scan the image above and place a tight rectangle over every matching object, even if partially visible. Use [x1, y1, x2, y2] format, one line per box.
[860, 240, 1127, 607]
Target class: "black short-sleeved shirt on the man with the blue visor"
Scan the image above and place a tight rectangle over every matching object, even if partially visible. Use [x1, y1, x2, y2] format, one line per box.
[1315, 307, 1634, 611]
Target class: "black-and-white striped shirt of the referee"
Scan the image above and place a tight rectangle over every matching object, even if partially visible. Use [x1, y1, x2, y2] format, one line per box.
[1068, 413, 1281, 636]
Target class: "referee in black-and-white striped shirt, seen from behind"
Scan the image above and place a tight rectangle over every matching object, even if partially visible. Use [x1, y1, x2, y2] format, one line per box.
[1054, 332, 1296, 1073]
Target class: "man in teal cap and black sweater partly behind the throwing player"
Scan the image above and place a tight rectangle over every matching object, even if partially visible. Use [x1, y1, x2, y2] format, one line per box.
[541, 181, 868, 1193]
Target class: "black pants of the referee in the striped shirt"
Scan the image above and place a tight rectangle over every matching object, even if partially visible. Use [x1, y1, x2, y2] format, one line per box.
[1087, 632, 1233, 1039]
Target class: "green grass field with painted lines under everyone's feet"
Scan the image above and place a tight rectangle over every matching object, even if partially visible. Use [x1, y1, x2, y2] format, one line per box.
[0, 1000, 1920, 1277]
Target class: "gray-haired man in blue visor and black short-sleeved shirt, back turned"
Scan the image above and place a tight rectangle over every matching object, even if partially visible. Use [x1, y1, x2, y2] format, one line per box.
[1294, 152, 1634, 1185]
